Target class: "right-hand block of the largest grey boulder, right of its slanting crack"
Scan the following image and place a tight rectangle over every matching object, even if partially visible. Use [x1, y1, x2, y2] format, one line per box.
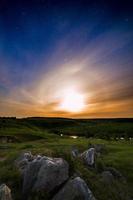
[34, 158, 69, 192]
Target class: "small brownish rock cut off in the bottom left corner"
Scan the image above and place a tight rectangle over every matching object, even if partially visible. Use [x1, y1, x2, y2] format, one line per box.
[0, 184, 12, 200]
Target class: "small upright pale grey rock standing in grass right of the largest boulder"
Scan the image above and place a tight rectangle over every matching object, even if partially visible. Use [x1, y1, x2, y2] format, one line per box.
[80, 148, 95, 167]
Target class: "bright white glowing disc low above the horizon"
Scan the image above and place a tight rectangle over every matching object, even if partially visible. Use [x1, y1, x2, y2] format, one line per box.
[59, 88, 85, 112]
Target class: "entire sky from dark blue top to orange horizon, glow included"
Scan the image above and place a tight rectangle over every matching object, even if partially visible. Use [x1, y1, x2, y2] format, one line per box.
[0, 0, 133, 118]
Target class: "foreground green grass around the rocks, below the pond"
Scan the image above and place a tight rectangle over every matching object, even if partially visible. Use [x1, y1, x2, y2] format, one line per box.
[0, 138, 133, 200]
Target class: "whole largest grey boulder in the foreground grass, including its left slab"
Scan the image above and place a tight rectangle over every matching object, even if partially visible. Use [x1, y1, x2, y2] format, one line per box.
[23, 156, 69, 197]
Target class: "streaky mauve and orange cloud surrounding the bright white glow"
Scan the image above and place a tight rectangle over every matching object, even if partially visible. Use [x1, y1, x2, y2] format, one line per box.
[0, 19, 133, 117]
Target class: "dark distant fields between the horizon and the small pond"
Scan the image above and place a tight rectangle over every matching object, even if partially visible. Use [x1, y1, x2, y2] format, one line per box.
[0, 117, 133, 139]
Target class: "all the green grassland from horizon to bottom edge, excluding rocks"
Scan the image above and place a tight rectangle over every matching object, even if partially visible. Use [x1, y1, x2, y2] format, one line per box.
[0, 118, 133, 200]
